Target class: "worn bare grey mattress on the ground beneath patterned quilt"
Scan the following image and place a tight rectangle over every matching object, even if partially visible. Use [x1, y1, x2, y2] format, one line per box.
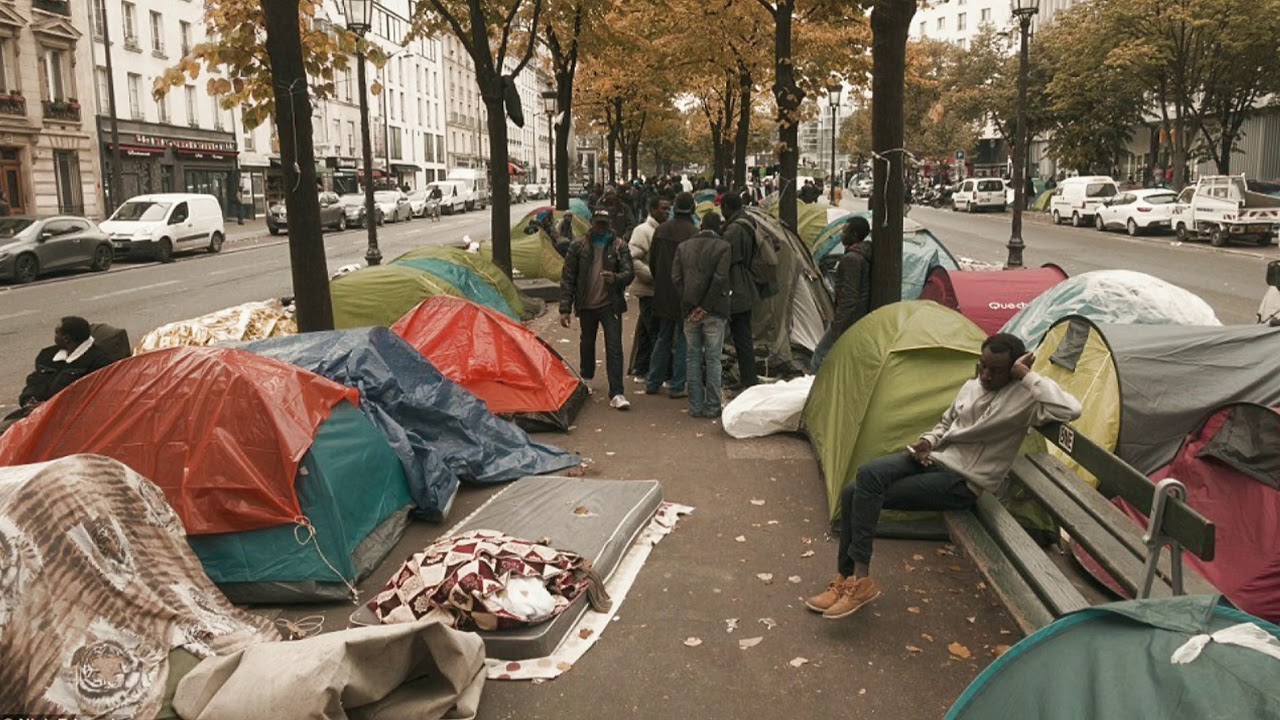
[352, 475, 662, 660]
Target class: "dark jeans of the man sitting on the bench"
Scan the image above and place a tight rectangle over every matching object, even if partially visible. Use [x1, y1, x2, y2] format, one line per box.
[837, 451, 978, 577]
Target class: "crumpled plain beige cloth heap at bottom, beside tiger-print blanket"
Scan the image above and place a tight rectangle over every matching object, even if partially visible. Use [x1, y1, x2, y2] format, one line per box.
[173, 621, 485, 720]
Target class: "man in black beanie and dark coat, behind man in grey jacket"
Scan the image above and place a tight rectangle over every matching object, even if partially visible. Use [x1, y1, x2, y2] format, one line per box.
[644, 192, 698, 397]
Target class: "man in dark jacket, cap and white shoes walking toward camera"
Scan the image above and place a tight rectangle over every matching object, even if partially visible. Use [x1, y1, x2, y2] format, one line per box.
[561, 210, 635, 410]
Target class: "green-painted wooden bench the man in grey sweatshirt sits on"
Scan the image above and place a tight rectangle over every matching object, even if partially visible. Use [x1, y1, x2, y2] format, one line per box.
[945, 423, 1217, 633]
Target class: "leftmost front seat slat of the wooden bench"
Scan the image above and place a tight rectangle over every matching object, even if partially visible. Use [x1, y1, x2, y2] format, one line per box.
[943, 510, 1053, 635]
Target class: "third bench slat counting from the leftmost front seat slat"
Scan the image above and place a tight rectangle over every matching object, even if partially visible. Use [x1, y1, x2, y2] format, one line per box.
[1011, 456, 1171, 597]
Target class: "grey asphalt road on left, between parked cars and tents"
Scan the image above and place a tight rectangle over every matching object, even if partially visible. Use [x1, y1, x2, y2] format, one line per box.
[0, 202, 540, 415]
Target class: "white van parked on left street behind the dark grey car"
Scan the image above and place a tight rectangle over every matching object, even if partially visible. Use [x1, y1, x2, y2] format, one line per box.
[100, 192, 227, 263]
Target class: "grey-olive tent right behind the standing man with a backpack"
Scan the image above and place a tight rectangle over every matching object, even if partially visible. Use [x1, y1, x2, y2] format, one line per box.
[744, 208, 835, 366]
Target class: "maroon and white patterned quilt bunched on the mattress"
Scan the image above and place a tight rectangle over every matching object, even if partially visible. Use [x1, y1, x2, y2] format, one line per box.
[369, 530, 608, 630]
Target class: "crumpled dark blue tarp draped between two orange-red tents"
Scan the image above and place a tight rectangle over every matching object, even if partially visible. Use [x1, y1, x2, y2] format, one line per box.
[242, 328, 580, 520]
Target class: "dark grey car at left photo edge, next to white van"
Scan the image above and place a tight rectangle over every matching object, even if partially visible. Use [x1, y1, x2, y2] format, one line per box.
[0, 215, 115, 283]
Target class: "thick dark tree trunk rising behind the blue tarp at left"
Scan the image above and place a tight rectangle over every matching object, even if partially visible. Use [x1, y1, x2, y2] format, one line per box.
[261, 0, 333, 332]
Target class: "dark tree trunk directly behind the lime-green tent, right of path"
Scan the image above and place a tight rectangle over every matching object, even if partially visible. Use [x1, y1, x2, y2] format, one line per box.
[872, 0, 915, 309]
